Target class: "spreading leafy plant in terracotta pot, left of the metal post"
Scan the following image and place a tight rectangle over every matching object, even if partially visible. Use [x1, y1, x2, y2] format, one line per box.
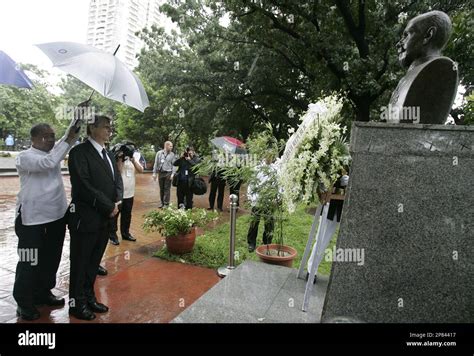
[143, 206, 217, 255]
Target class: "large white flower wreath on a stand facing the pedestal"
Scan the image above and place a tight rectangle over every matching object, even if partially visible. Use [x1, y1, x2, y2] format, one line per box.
[279, 96, 350, 212]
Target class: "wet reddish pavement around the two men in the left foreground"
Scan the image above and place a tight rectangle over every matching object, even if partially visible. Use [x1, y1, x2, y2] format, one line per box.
[0, 173, 243, 323]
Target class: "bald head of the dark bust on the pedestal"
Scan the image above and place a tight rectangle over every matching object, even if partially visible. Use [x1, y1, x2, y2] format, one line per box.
[397, 11, 452, 68]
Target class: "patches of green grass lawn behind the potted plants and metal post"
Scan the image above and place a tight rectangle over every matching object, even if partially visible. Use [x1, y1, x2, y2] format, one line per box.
[155, 206, 338, 275]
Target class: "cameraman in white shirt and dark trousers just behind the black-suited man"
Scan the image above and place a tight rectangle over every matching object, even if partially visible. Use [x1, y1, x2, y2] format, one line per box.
[109, 142, 143, 245]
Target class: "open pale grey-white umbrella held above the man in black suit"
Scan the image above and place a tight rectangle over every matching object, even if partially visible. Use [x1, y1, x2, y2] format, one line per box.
[36, 42, 150, 112]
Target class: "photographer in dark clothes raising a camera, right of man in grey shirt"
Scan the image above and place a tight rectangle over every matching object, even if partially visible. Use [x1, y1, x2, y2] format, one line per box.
[174, 147, 201, 210]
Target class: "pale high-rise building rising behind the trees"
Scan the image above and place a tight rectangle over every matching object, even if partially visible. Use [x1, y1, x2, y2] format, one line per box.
[87, 0, 167, 69]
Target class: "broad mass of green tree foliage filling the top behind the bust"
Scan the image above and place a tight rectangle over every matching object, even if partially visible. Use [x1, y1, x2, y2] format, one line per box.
[128, 0, 473, 147]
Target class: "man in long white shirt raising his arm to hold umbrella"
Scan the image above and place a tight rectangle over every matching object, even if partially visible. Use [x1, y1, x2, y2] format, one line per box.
[13, 123, 79, 320]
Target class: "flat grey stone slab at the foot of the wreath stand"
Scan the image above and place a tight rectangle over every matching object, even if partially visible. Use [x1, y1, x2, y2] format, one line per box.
[173, 261, 329, 323]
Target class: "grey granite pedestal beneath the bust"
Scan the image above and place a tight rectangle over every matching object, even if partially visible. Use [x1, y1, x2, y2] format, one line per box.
[322, 123, 474, 323]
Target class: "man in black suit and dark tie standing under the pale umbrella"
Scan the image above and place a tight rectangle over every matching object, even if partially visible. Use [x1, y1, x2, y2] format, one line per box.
[68, 115, 123, 320]
